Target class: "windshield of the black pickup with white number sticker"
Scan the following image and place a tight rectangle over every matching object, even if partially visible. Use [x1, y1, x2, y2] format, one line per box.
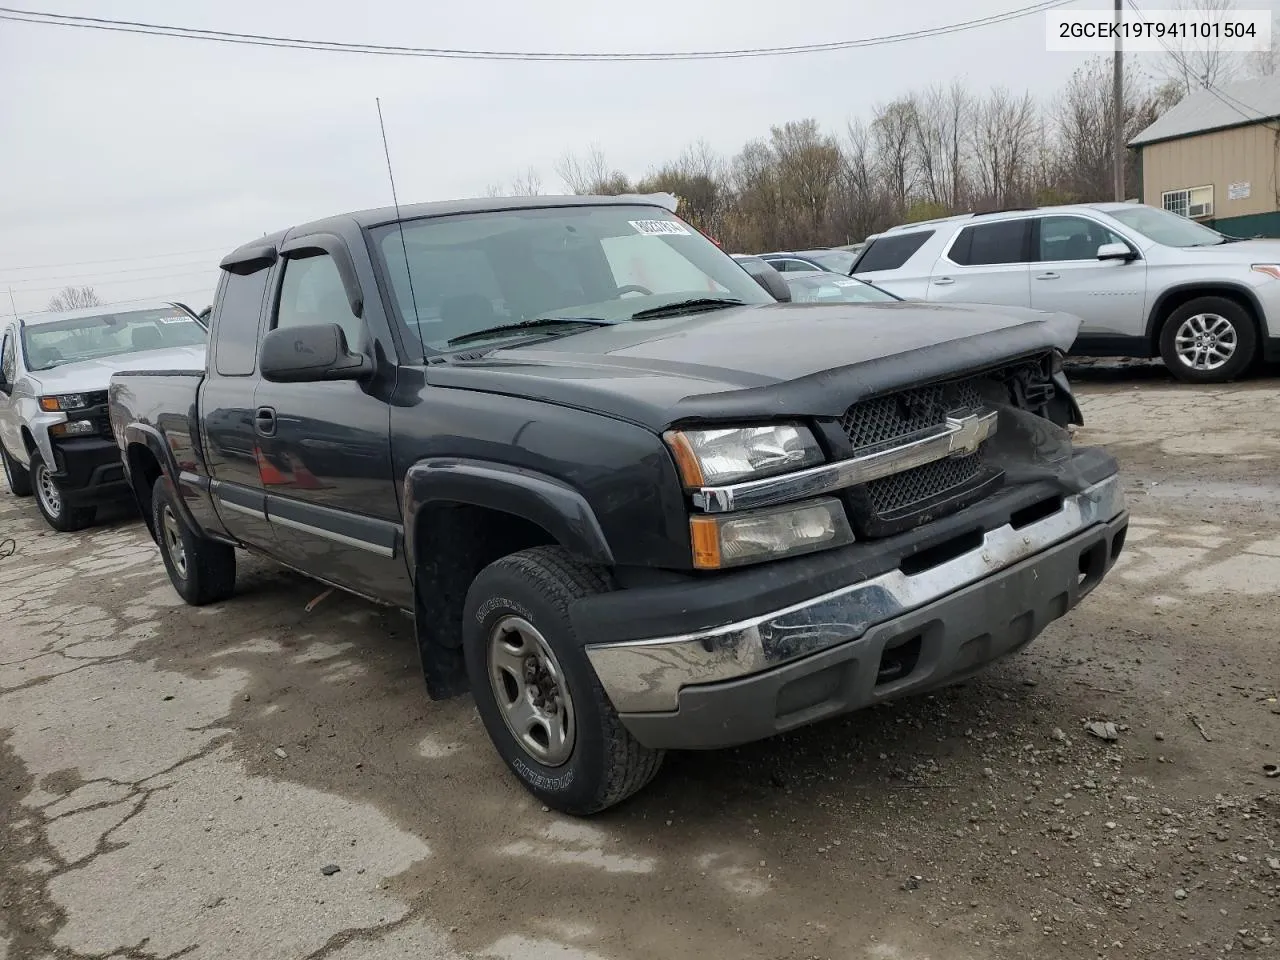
[374, 205, 774, 351]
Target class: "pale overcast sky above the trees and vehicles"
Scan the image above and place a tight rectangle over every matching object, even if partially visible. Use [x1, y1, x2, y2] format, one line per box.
[0, 0, 1277, 315]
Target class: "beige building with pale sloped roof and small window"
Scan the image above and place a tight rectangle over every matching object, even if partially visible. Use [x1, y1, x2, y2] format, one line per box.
[1129, 77, 1280, 237]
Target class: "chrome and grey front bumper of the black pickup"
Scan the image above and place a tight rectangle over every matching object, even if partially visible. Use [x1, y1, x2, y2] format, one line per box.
[580, 471, 1128, 749]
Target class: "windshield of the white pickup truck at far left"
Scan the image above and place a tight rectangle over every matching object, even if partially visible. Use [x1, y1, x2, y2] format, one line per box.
[22, 307, 207, 370]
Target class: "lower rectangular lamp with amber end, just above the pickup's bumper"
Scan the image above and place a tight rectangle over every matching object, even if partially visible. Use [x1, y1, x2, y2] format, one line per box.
[689, 499, 854, 570]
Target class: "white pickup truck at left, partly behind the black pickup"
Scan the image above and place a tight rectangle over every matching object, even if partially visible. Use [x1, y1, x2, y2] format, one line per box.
[0, 302, 209, 531]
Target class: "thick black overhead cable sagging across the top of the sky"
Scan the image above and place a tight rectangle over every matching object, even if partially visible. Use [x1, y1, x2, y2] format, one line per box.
[0, 0, 1073, 63]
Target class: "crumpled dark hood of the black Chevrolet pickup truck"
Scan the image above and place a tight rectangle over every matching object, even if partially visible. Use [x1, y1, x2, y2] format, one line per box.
[426, 302, 1079, 430]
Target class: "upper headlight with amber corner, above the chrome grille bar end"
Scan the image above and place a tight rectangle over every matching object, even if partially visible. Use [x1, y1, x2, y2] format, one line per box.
[666, 424, 823, 490]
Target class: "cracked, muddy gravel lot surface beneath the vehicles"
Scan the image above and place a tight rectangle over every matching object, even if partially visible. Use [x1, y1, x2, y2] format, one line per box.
[0, 365, 1280, 960]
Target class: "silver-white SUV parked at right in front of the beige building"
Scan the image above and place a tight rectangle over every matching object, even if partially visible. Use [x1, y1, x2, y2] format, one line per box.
[851, 204, 1280, 383]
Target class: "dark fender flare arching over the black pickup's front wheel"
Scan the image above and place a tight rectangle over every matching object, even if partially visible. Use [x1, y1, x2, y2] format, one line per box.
[402, 457, 613, 570]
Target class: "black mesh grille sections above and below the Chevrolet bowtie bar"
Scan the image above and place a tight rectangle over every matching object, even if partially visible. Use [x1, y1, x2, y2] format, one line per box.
[840, 378, 998, 536]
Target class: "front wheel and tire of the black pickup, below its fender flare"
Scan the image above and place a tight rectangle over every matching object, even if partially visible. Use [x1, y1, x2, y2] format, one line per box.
[462, 547, 663, 817]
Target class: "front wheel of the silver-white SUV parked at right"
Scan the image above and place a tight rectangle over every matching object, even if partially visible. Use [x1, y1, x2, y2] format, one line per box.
[1160, 297, 1258, 383]
